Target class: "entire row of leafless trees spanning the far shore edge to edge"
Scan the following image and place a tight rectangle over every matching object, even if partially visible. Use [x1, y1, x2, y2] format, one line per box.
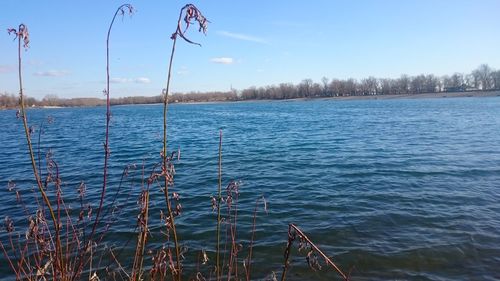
[0, 64, 500, 108]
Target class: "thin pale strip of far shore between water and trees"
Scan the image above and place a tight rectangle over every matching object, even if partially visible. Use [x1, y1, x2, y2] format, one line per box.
[0, 91, 500, 110]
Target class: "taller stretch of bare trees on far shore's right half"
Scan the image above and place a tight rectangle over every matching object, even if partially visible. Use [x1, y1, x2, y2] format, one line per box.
[240, 64, 500, 100]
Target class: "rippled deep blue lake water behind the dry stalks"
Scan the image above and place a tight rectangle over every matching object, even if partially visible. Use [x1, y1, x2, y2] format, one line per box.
[0, 97, 500, 280]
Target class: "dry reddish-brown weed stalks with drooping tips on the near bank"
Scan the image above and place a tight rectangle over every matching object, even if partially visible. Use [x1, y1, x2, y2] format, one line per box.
[0, 4, 349, 281]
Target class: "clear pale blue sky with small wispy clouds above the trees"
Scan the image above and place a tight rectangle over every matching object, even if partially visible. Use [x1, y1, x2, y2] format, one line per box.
[0, 0, 500, 99]
